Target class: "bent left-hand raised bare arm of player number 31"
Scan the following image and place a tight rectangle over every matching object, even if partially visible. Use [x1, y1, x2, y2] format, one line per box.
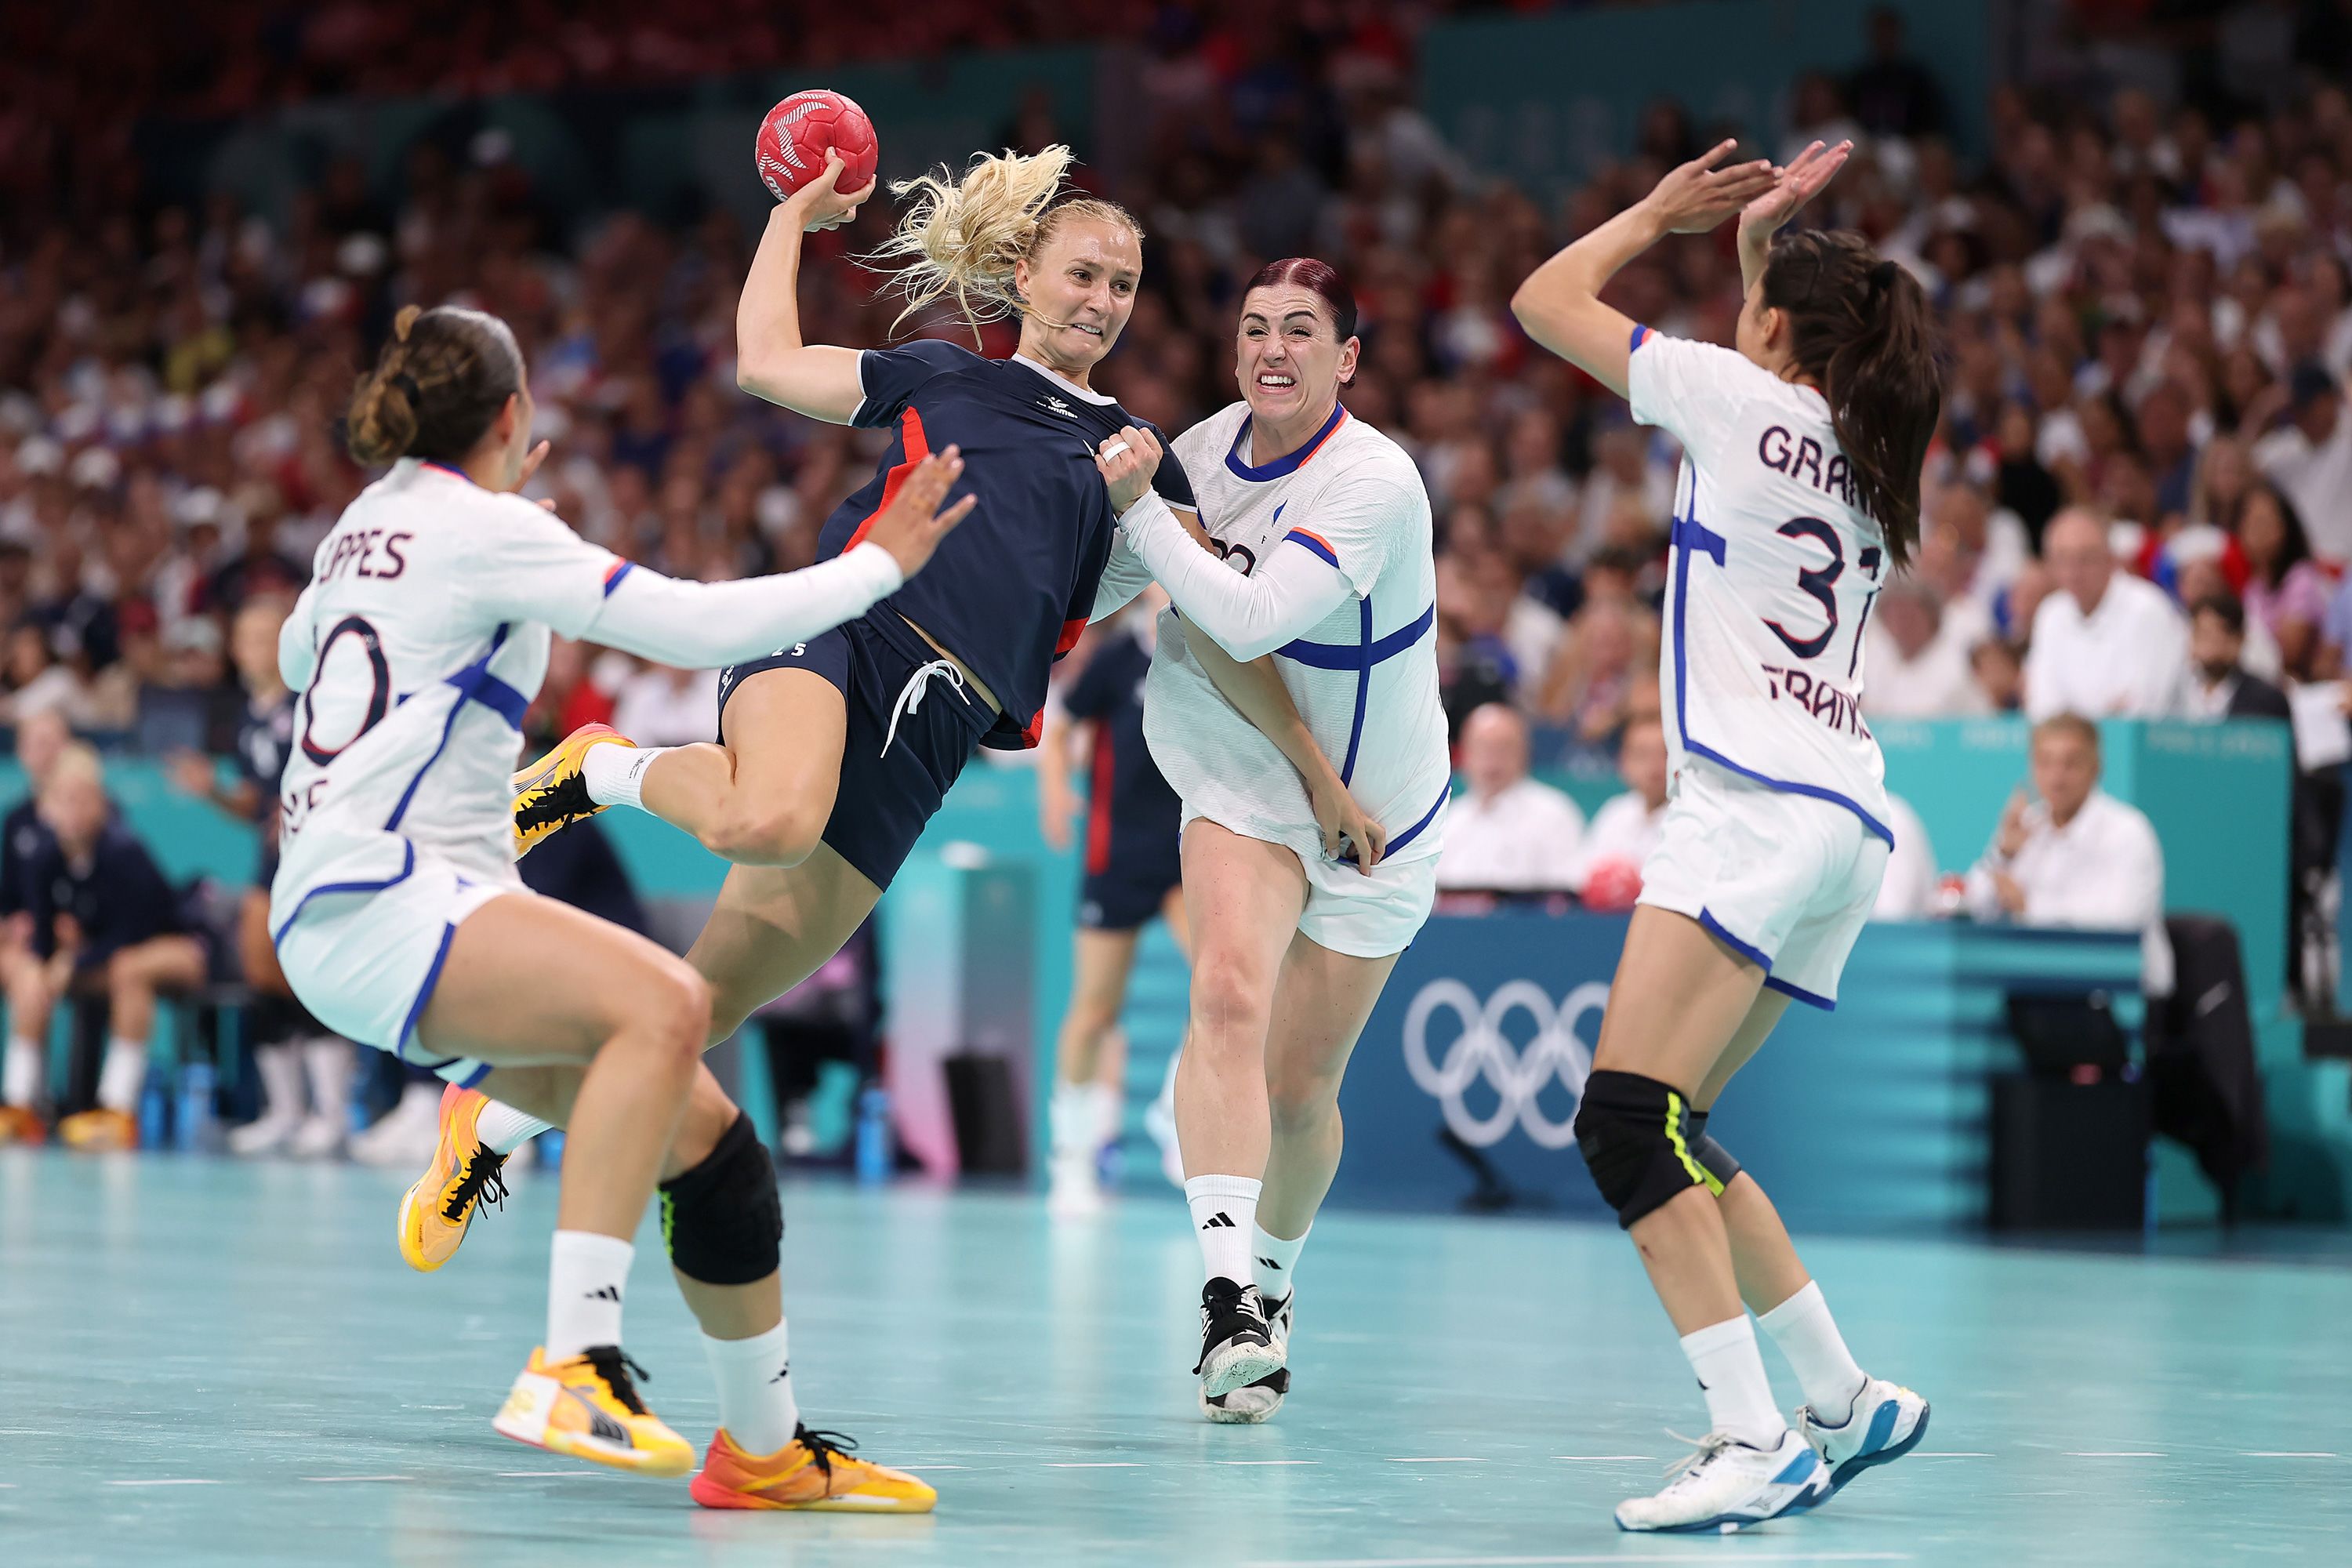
[1510, 141, 1780, 397]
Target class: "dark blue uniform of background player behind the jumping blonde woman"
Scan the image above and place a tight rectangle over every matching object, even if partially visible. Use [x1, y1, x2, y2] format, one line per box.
[1063, 626, 1183, 931]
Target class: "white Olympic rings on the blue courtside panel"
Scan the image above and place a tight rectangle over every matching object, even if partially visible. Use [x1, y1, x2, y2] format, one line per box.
[1404, 978, 1609, 1149]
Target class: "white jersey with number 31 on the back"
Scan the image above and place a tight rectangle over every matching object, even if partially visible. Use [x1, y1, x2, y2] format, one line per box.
[1625, 327, 1893, 844]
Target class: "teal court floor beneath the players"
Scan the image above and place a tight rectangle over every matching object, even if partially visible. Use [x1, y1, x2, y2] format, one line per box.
[0, 1149, 2352, 1568]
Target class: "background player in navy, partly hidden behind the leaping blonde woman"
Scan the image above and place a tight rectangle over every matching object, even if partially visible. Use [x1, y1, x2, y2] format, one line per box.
[1040, 595, 1192, 1215]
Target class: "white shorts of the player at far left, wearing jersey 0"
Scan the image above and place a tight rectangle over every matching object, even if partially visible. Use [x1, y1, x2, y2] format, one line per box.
[270, 834, 527, 1088]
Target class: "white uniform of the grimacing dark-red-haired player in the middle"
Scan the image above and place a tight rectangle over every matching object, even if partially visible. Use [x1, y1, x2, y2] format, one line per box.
[1096, 402, 1454, 959]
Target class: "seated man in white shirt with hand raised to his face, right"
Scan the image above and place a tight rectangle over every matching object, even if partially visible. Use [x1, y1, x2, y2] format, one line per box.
[1969, 713, 2173, 996]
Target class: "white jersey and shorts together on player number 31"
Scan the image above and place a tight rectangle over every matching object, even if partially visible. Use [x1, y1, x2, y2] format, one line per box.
[1625, 327, 1893, 1008]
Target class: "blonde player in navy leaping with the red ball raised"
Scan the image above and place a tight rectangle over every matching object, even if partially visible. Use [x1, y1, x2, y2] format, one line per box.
[409, 146, 1369, 1457]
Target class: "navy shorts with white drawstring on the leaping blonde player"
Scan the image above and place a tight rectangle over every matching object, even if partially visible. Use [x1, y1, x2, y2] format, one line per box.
[720, 609, 997, 888]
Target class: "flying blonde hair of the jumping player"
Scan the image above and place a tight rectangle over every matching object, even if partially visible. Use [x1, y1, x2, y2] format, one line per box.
[863, 143, 1143, 339]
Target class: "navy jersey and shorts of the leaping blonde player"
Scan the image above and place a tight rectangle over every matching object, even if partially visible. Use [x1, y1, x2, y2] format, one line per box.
[720, 341, 1195, 886]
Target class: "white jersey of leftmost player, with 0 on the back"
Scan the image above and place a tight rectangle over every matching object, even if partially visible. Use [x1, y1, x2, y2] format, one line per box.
[273, 459, 628, 926]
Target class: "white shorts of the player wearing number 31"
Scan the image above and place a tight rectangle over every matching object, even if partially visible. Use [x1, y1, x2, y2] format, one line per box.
[1642, 757, 1889, 1008]
